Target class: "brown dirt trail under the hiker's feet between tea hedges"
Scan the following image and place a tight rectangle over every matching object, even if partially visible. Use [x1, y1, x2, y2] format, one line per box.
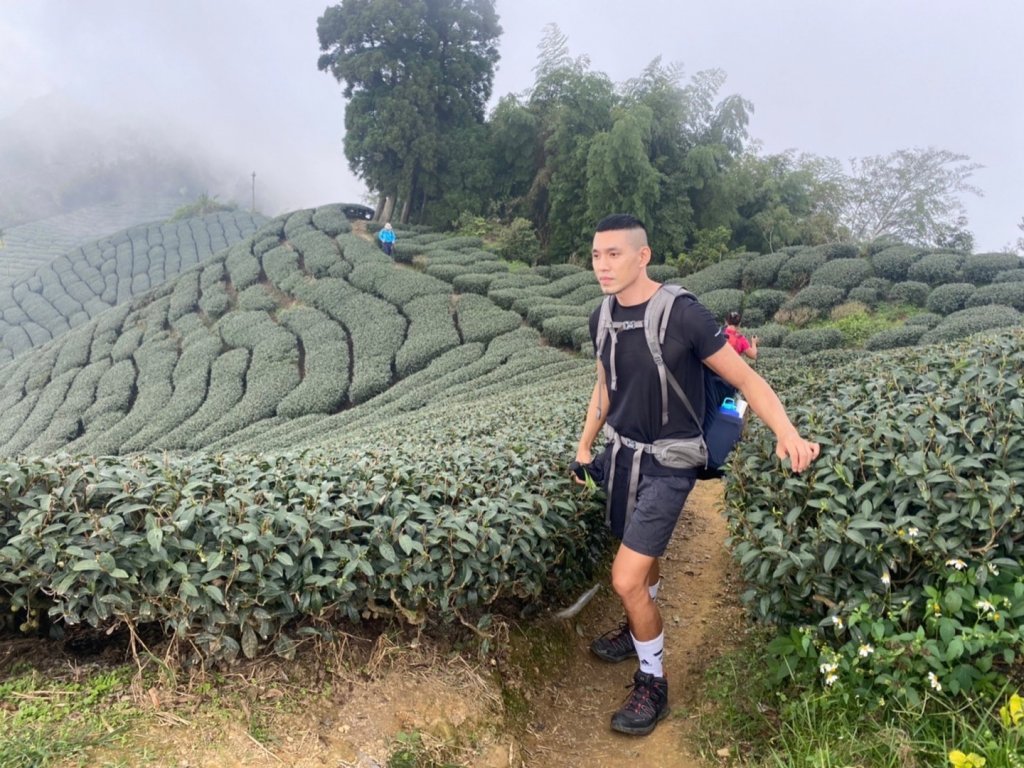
[523, 480, 741, 768]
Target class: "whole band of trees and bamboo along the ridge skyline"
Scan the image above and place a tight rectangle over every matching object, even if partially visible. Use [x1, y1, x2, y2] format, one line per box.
[317, 10, 979, 264]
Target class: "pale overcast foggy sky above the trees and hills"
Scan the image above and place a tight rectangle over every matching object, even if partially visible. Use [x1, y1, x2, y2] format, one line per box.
[0, 0, 1024, 251]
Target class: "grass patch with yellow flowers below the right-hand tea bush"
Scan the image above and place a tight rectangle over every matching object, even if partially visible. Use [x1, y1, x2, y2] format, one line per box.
[693, 630, 1024, 768]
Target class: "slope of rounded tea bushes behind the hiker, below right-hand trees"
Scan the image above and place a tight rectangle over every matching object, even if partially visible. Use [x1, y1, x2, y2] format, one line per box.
[673, 245, 1024, 356]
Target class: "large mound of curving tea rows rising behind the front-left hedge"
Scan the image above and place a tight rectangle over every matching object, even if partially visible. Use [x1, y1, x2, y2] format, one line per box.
[0, 207, 552, 455]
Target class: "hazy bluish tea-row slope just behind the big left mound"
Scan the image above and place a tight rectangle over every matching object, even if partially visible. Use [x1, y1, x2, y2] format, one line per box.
[0, 211, 266, 362]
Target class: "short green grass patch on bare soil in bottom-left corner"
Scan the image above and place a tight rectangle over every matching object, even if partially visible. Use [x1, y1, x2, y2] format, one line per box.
[0, 668, 139, 768]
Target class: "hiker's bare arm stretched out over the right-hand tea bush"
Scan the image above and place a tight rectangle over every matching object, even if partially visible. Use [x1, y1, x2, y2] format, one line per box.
[703, 345, 820, 472]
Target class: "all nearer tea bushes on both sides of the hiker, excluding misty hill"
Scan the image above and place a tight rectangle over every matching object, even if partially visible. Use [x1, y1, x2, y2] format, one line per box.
[0, 206, 1024, 698]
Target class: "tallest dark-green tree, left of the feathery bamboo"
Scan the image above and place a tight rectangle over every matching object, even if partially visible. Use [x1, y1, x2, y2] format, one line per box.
[316, 0, 502, 222]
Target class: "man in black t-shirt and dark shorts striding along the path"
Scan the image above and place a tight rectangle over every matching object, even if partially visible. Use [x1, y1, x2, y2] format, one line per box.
[575, 214, 819, 735]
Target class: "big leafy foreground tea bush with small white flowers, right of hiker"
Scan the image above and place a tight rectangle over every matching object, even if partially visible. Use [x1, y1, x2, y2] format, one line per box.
[727, 331, 1024, 698]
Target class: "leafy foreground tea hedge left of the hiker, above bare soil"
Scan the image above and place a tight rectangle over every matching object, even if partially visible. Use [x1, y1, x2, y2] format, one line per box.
[0, 376, 605, 660]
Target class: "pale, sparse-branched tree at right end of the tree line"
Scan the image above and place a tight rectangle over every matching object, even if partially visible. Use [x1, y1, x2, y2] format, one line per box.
[842, 147, 981, 247]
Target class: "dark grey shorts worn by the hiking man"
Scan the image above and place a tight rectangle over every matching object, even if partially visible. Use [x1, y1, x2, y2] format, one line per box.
[611, 475, 696, 557]
